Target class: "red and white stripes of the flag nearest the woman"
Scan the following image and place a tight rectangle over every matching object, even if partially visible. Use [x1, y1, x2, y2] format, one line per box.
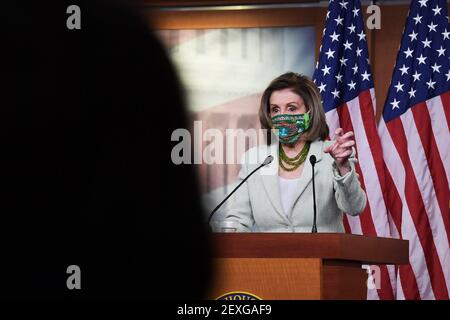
[326, 89, 396, 299]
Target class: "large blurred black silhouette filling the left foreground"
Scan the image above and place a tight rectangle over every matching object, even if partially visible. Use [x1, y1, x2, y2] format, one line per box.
[0, 1, 209, 299]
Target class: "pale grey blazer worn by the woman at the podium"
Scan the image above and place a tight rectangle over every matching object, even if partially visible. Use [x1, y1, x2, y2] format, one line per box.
[225, 140, 367, 232]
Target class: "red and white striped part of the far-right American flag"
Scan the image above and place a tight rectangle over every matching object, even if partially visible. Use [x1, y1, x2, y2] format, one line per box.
[378, 92, 450, 299]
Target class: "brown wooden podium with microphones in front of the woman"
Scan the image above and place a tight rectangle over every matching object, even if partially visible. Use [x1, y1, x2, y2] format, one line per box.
[209, 233, 409, 300]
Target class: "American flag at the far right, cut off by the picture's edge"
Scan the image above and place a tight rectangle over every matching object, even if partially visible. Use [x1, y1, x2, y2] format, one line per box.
[379, 0, 450, 299]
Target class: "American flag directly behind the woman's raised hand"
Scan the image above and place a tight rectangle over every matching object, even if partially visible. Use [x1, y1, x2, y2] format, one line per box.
[314, 0, 395, 299]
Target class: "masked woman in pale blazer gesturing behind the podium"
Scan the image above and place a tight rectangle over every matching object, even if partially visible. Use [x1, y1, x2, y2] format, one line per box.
[223, 73, 366, 232]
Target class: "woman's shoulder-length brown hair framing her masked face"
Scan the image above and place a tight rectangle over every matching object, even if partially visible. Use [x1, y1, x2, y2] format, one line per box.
[259, 72, 329, 144]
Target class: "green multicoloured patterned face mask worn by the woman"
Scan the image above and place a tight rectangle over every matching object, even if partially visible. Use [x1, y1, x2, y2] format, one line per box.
[272, 111, 310, 144]
